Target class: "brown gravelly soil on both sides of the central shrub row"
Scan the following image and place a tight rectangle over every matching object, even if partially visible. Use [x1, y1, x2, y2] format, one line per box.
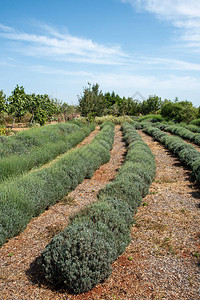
[0, 128, 200, 300]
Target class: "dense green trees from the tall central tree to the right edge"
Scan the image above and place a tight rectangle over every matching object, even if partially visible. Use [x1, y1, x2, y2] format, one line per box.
[78, 83, 200, 122]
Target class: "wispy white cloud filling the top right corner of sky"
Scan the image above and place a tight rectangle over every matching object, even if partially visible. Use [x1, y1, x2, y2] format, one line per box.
[122, 0, 200, 49]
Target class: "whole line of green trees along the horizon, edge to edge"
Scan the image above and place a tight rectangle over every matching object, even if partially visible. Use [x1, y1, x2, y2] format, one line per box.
[0, 83, 200, 126]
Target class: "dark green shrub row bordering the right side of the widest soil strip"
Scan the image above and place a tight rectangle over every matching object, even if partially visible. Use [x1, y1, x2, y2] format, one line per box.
[143, 126, 200, 182]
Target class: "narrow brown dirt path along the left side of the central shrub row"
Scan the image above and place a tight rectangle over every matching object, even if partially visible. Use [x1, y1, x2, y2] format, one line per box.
[0, 126, 126, 300]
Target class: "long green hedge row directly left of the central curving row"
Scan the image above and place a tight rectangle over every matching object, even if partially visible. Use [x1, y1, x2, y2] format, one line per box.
[0, 124, 114, 245]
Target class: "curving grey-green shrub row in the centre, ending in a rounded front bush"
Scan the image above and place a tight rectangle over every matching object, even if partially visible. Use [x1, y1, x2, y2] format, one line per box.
[41, 123, 155, 294]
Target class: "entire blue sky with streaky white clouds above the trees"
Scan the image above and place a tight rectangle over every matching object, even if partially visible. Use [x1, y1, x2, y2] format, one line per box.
[0, 0, 200, 106]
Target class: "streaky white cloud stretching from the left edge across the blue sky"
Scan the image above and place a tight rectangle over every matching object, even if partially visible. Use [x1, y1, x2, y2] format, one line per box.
[0, 24, 126, 64]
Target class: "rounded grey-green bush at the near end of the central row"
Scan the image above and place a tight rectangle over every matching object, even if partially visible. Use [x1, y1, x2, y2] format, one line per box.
[42, 223, 113, 294]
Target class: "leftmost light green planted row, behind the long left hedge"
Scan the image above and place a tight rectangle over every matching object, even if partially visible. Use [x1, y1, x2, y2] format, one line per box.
[0, 123, 94, 181]
